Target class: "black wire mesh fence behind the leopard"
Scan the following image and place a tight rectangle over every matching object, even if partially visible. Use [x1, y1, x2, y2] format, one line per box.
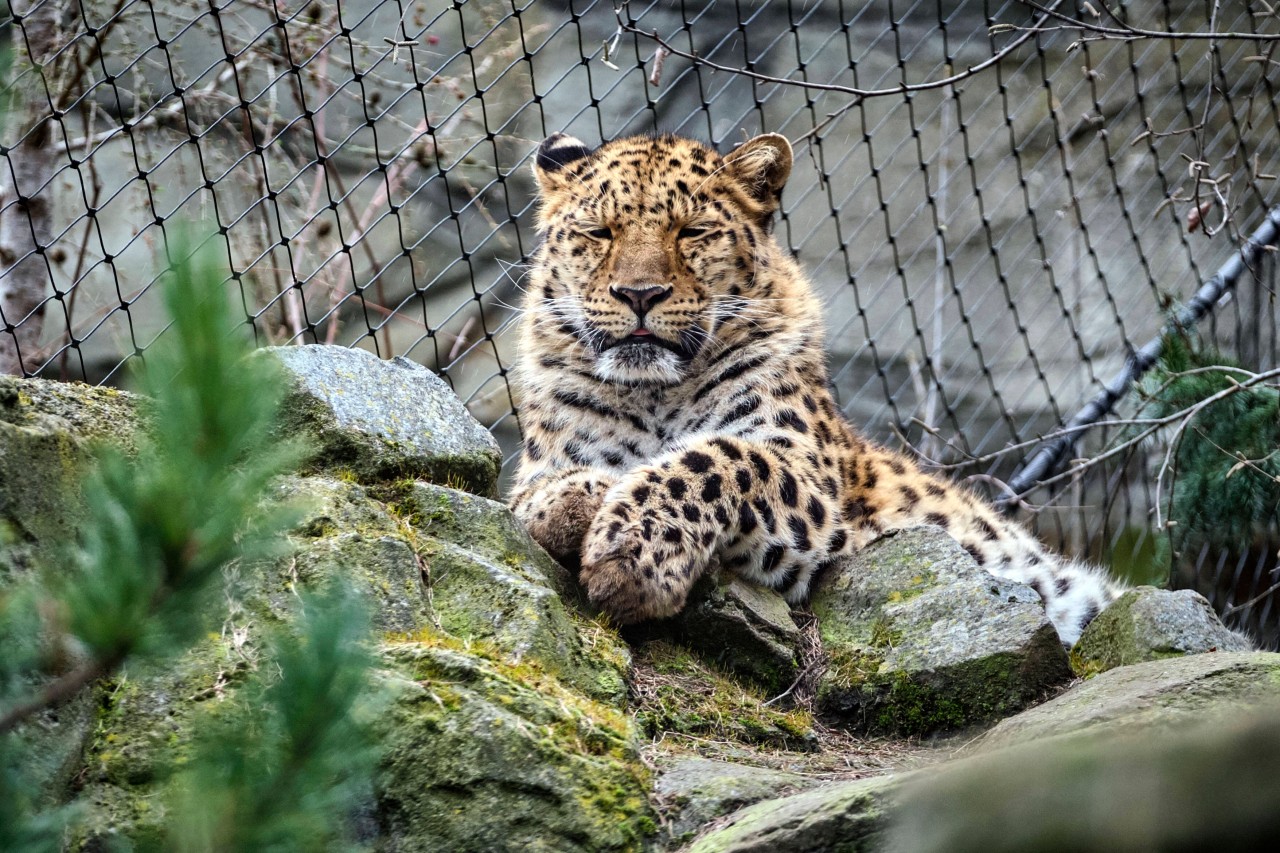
[0, 0, 1280, 643]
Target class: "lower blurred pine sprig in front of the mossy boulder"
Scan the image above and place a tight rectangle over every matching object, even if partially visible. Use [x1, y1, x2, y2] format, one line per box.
[166, 587, 376, 853]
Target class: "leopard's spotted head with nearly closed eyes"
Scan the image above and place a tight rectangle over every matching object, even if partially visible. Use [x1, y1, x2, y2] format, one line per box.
[530, 133, 792, 386]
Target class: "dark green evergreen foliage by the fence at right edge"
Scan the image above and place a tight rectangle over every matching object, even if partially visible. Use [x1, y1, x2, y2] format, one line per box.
[1140, 334, 1280, 549]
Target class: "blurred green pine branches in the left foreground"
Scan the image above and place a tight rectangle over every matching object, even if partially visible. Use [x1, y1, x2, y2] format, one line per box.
[0, 252, 372, 850]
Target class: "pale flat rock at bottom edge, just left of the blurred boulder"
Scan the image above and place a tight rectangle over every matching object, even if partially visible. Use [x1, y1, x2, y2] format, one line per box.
[686, 775, 911, 853]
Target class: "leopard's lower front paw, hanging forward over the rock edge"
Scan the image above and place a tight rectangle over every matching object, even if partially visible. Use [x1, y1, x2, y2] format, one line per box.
[579, 503, 709, 625]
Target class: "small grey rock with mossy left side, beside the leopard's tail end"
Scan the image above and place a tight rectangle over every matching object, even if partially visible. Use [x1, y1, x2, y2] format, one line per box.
[1071, 587, 1253, 675]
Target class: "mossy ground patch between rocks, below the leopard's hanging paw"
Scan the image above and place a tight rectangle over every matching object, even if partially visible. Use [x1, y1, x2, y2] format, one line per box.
[632, 640, 815, 749]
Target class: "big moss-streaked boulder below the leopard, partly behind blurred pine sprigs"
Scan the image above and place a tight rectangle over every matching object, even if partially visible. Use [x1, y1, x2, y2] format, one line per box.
[64, 468, 634, 850]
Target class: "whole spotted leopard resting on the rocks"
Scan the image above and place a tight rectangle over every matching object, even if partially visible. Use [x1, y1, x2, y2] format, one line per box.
[509, 133, 1124, 646]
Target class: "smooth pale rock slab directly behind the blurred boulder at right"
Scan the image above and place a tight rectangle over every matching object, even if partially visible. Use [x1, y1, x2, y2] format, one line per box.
[979, 652, 1280, 748]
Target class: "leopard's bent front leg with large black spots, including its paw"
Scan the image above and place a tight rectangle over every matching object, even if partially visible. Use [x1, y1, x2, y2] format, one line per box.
[581, 437, 845, 622]
